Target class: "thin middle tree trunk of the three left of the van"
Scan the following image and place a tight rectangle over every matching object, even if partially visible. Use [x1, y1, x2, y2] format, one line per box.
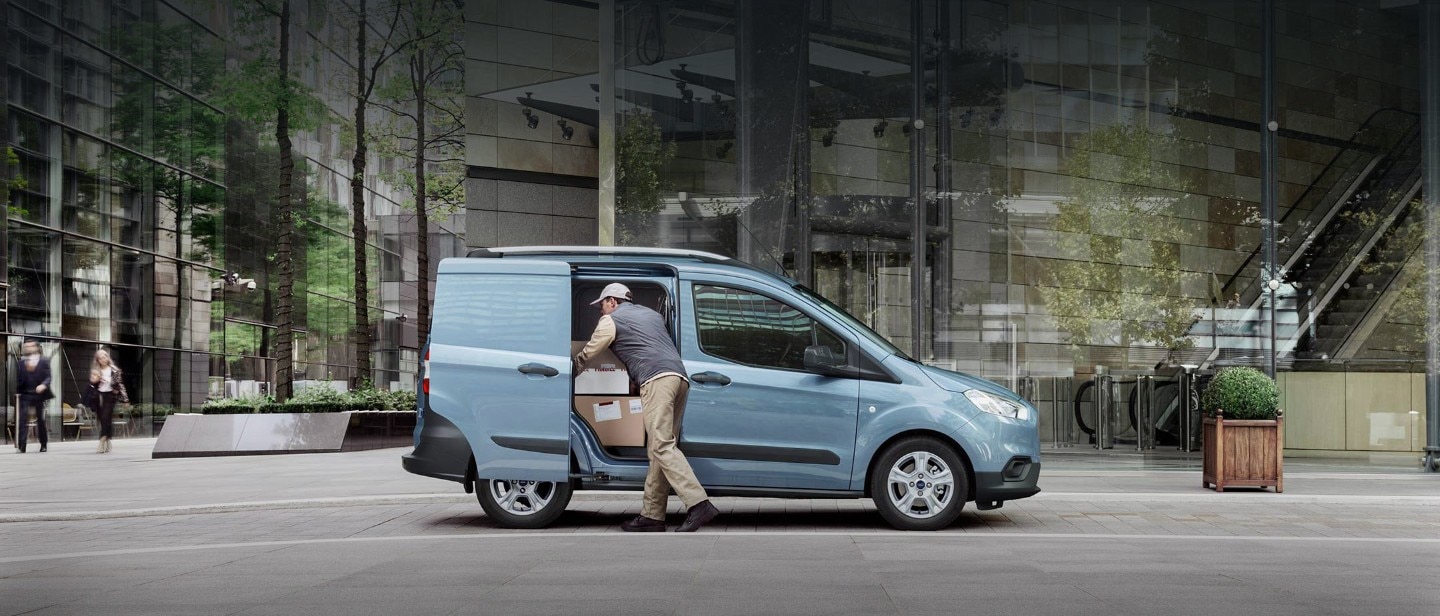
[350, 0, 372, 384]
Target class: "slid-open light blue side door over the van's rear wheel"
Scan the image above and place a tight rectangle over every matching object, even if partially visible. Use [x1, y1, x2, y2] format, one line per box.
[429, 259, 570, 481]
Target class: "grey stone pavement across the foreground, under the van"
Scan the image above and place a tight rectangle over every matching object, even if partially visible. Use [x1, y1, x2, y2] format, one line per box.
[0, 440, 1440, 616]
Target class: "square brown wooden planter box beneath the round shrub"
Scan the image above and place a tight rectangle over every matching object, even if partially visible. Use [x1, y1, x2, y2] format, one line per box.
[1201, 412, 1284, 492]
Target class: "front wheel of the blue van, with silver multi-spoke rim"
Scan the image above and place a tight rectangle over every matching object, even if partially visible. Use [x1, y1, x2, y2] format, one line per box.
[870, 436, 971, 531]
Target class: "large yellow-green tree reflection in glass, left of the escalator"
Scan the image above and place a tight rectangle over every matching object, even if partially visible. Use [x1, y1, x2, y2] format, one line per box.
[1037, 125, 1200, 361]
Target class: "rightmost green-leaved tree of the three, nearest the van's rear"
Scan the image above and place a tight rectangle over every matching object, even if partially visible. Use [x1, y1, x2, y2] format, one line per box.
[380, 0, 465, 337]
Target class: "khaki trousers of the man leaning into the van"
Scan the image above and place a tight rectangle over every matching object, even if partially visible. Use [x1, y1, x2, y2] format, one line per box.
[639, 376, 710, 520]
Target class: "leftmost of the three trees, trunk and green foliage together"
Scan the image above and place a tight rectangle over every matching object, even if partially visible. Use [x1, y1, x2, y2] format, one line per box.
[217, 0, 325, 402]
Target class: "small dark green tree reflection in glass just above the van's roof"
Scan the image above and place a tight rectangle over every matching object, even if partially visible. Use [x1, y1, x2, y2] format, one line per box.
[615, 112, 675, 246]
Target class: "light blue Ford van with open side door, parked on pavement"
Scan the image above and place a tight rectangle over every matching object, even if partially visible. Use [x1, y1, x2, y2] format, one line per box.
[403, 246, 1040, 530]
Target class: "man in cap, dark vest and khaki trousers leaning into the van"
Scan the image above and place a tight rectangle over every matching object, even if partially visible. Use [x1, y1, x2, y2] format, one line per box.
[575, 282, 720, 533]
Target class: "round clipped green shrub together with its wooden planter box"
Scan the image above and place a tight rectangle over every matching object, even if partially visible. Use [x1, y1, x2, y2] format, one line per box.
[1201, 367, 1284, 492]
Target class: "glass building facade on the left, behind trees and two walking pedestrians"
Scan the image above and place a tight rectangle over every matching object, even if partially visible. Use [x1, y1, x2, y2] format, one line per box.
[0, 0, 459, 439]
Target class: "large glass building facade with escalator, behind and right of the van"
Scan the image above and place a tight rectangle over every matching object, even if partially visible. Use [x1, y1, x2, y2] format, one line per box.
[467, 0, 1440, 453]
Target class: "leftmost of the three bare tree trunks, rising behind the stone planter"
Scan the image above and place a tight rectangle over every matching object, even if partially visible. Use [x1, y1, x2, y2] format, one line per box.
[275, 0, 295, 402]
